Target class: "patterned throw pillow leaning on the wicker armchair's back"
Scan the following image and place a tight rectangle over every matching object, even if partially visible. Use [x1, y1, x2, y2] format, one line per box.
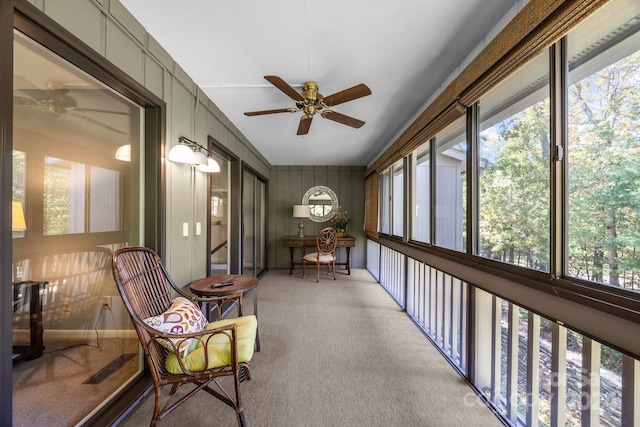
[144, 297, 208, 357]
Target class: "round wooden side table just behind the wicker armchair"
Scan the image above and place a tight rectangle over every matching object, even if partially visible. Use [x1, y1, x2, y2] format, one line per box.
[189, 274, 260, 351]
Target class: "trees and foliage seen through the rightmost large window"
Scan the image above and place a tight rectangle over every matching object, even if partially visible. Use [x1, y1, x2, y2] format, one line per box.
[568, 53, 640, 289]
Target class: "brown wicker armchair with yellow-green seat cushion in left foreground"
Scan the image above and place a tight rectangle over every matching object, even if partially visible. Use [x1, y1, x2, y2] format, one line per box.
[112, 247, 257, 426]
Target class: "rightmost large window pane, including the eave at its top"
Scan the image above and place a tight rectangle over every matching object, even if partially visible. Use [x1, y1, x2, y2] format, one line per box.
[566, 0, 640, 291]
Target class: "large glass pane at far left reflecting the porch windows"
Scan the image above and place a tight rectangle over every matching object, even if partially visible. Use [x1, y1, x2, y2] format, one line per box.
[12, 32, 144, 425]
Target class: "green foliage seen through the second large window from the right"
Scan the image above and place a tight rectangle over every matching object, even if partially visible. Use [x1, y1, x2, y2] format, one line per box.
[479, 100, 549, 271]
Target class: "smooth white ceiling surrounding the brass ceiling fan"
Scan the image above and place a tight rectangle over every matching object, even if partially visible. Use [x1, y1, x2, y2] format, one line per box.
[121, 0, 518, 166]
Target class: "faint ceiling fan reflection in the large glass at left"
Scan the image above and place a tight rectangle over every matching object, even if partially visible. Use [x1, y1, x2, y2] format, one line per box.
[13, 80, 129, 134]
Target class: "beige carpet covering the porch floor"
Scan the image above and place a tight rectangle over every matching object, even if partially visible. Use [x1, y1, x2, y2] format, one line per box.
[123, 270, 502, 427]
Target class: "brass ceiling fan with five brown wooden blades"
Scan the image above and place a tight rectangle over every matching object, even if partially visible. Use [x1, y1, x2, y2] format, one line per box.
[244, 76, 371, 135]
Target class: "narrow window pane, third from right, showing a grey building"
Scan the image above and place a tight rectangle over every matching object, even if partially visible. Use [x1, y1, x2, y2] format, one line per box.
[434, 118, 467, 251]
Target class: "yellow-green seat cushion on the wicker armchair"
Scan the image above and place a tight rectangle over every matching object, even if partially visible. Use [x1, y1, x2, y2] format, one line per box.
[165, 315, 258, 374]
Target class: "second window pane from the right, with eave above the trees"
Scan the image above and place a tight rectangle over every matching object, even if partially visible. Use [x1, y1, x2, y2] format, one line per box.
[477, 52, 550, 271]
